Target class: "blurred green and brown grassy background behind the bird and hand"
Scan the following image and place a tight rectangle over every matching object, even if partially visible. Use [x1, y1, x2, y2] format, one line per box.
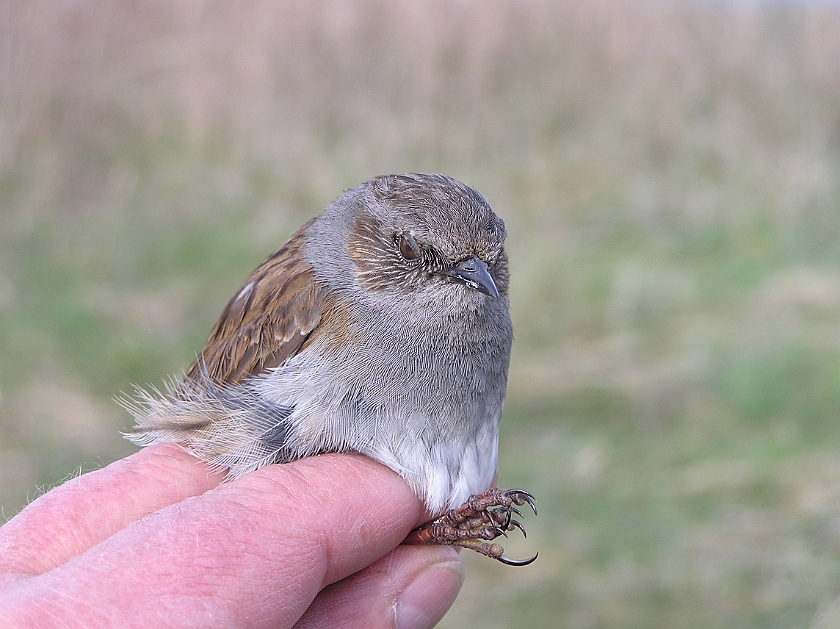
[0, 0, 840, 629]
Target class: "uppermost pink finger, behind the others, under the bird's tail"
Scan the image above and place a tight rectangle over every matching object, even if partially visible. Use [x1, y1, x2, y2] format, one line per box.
[0, 445, 222, 583]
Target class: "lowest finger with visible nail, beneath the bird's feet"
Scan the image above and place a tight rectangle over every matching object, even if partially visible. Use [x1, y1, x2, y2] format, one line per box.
[295, 546, 464, 629]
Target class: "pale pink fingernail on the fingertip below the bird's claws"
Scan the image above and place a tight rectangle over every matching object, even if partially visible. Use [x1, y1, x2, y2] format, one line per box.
[396, 561, 464, 629]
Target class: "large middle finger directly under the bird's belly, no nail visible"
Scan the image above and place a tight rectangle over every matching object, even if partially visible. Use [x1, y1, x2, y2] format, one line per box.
[3, 455, 423, 627]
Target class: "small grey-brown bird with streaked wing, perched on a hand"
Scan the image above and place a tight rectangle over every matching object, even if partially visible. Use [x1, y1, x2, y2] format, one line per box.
[124, 174, 536, 565]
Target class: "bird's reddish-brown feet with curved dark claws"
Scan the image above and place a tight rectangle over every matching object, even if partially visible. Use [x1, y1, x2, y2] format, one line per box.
[403, 487, 537, 566]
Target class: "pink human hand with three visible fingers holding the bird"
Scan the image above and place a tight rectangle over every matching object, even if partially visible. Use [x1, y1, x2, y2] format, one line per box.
[0, 445, 463, 629]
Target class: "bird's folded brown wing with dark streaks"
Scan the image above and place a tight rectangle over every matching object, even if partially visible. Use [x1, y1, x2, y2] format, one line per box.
[187, 221, 324, 384]
